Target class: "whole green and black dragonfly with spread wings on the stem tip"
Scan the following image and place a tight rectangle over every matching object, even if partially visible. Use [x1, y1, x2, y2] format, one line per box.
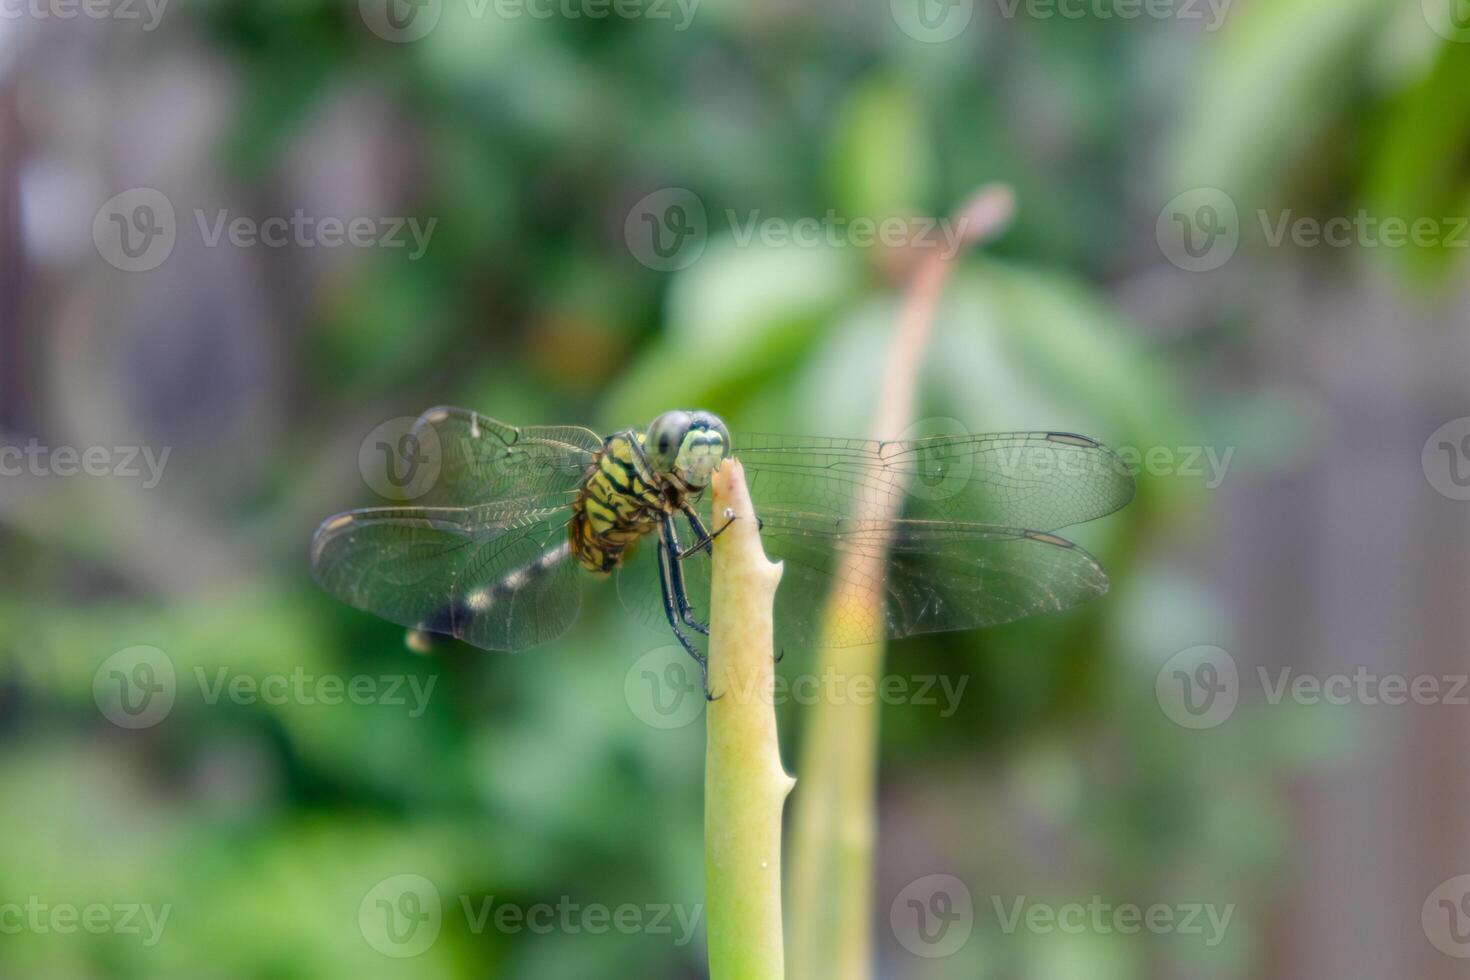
[312, 407, 1133, 681]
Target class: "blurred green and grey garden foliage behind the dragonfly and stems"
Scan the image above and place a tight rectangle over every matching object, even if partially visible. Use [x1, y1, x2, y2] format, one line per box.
[0, 0, 1470, 980]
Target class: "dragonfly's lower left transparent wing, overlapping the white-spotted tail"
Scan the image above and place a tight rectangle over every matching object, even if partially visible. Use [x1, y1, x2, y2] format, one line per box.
[312, 505, 582, 651]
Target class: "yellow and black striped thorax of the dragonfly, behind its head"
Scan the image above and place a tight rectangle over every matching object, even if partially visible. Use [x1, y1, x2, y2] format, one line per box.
[569, 433, 666, 572]
